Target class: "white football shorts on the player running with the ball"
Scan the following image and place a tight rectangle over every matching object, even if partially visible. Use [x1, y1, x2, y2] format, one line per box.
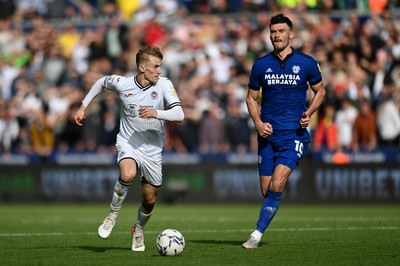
[115, 138, 162, 187]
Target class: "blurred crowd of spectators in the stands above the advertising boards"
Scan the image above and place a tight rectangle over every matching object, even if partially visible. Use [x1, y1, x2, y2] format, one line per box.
[0, 0, 400, 160]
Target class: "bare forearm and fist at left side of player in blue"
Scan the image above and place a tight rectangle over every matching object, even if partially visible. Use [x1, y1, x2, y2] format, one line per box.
[246, 89, 273, 138]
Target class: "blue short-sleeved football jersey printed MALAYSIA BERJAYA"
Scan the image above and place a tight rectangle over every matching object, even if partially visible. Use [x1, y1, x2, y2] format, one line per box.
[249, 50, 322, 130]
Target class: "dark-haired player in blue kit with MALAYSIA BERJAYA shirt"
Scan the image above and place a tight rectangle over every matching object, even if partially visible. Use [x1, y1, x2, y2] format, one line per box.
[242, 14, 326, 248]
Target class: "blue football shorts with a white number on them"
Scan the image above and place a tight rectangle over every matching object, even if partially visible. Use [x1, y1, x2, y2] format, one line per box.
[258, 129, 310, 176]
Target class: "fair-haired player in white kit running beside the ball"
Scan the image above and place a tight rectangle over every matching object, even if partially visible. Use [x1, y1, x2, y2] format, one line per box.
[74, 46, 184, 251]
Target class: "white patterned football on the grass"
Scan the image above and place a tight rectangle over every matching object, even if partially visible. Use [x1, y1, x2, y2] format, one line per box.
[156, 229, 185, 256]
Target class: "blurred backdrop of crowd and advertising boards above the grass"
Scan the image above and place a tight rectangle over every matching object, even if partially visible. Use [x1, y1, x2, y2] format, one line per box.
[0, 0, 400, 204]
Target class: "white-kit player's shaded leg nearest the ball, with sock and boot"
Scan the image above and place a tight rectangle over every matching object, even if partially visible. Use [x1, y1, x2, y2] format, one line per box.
[132, 179, 159, 251]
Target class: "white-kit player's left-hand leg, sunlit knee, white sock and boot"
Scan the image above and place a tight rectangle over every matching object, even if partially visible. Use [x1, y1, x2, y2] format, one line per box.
[98, 158, 137, 238]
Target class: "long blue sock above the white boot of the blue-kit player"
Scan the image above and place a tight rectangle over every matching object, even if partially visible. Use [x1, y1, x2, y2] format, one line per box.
[256, 189, 282, 233]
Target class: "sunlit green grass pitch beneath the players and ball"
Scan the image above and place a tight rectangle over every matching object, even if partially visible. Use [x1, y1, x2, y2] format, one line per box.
[0, 203, 400, 266]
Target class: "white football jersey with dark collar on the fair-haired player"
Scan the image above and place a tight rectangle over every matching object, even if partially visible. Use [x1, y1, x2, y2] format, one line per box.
[103, 75, 181, 156]
